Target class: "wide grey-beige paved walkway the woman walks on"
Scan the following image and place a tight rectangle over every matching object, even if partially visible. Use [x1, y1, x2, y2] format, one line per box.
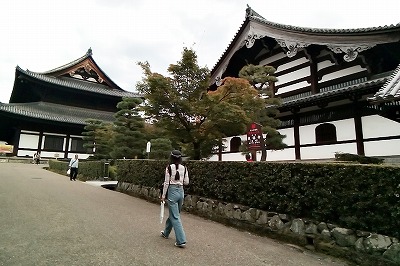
[0, 163, 346, 266]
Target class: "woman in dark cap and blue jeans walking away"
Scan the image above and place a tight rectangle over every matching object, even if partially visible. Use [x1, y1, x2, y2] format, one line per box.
[161, 150, 189, 248]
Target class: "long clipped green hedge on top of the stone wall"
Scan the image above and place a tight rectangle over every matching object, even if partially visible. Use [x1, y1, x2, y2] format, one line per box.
[116, 160, 400, 237]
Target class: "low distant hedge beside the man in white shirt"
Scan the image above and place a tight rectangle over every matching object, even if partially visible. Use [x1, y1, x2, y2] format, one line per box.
[49, 160, 115, 181]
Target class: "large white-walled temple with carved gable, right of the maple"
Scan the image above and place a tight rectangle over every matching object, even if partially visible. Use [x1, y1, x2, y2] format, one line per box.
[211, 7, 400, 161]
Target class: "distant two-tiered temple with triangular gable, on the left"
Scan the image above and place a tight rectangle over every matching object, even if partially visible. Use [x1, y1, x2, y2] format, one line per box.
[0, 49, 140, 158]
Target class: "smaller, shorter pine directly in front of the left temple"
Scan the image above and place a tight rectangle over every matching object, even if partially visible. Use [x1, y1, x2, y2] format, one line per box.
[82, 119, 114, 160]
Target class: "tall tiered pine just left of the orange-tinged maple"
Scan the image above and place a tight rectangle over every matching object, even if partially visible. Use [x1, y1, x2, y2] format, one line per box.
[110, 97, 147, 158]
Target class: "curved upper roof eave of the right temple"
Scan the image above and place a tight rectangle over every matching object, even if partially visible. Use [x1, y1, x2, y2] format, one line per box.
[211, 8, 400, 83]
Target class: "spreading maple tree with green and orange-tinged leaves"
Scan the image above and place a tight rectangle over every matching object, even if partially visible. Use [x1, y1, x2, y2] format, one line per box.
[137, 48, 263, 160]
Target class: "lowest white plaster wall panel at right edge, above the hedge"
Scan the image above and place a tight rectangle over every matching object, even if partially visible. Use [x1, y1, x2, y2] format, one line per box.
[364, 139, 400, 156]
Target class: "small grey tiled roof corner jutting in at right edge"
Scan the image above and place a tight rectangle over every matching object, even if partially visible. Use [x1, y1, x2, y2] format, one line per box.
[368, 65, 400, 103]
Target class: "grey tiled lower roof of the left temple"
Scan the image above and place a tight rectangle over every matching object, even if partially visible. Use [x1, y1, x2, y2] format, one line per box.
[0, 102, 115, 125]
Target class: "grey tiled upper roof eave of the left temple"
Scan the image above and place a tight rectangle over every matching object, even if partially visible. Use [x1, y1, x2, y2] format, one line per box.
[17, 66, 141, 97]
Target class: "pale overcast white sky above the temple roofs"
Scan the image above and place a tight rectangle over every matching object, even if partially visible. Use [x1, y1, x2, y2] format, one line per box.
[0, 0, 400, 103]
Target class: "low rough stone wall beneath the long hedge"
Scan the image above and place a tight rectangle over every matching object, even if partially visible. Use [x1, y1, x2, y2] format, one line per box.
[116, 182, 400, 266]
